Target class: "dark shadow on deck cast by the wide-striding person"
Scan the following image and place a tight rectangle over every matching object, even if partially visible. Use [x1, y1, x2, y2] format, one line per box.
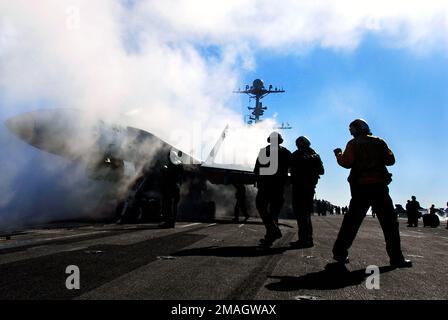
[266, 266, 394, 291]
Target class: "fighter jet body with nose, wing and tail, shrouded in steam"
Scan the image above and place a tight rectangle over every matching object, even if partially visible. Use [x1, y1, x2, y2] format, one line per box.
[6, 109, 254, 184]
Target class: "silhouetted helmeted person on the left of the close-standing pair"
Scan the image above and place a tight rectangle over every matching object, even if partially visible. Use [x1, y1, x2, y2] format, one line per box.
[254, 132, 291, 247]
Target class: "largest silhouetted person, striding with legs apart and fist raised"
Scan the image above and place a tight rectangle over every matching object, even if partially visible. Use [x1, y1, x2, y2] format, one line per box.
[333, 119, 412, 268]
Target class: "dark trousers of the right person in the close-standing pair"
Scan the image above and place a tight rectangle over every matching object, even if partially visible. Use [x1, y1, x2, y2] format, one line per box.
[292, 184, 315, 242]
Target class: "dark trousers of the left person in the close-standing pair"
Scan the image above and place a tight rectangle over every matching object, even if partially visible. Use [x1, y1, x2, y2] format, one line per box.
[255, 185, 284, 238]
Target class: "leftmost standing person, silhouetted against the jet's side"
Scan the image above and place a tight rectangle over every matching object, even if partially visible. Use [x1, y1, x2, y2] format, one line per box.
[159, 153, 183, 228]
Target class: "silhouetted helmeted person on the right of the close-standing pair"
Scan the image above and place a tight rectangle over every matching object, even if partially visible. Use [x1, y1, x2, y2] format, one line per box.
[290, 136, 324, 248]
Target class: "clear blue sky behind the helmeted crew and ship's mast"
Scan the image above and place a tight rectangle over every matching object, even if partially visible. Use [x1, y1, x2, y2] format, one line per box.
[236, 37, 448, 207]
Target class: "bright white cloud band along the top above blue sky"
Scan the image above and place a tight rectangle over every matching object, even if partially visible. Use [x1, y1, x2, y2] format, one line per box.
[135, 0, 448, 50]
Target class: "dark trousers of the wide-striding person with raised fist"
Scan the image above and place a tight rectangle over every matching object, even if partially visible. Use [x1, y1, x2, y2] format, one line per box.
[333, 184, 403, 261]
